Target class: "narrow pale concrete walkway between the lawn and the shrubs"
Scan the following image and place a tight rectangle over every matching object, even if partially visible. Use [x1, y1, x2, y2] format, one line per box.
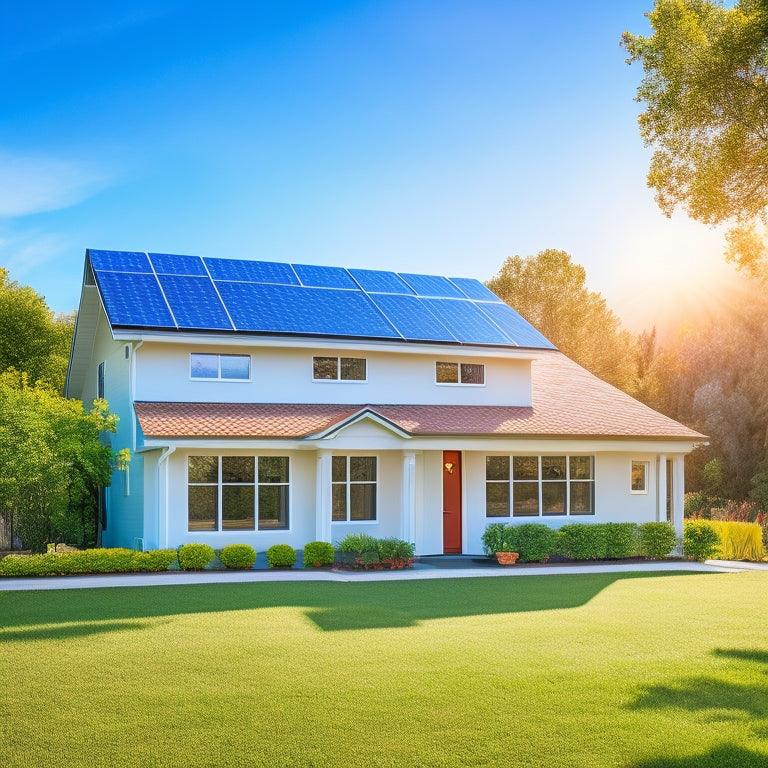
[0, 557, 768, 591]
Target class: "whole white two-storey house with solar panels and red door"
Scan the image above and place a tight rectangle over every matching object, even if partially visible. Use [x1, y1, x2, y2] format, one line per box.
[67, 250, 703, 554]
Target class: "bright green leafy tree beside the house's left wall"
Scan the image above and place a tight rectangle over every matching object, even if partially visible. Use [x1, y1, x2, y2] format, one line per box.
[0, 371, 119, 551]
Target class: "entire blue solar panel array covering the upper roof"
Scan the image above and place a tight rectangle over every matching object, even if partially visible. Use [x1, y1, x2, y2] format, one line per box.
[87, 250, 553, 349]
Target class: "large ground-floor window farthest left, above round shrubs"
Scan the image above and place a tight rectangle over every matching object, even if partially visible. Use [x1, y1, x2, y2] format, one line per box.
[187, 456, 289, 531]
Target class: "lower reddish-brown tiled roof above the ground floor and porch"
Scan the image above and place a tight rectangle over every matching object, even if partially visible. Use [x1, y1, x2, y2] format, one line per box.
[136, 351, 705, 441]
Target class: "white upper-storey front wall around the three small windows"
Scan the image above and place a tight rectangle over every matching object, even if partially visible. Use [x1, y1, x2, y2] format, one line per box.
[135, 342, 531, 405]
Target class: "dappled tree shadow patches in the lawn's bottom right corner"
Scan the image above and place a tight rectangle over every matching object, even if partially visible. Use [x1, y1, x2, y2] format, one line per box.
[626, 648, 768, 768]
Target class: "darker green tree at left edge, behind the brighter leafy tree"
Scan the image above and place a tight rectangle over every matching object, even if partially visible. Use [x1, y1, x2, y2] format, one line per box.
[0, 267, 75, 392]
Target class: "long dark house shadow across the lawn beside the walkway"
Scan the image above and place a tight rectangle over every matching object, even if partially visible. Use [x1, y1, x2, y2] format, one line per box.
[0, 571, 717, 645]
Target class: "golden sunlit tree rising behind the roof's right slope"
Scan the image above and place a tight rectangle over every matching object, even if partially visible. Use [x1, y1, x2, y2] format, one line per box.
[487, 249, 635, 390]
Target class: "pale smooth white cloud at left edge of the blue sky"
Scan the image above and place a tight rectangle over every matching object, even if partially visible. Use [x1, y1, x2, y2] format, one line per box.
[0, 152, 110, 219]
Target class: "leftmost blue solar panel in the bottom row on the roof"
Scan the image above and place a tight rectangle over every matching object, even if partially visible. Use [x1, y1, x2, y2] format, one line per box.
[96, 272, 176, 328]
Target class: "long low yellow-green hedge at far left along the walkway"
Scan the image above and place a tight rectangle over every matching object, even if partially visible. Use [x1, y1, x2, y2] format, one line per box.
[0, 548, 176, 576]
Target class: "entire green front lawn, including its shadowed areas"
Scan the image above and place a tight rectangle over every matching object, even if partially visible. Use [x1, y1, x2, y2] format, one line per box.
[0, 572, 768, 768]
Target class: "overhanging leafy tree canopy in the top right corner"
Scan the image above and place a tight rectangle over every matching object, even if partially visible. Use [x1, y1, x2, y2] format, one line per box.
[622, 0, 768, 275]
